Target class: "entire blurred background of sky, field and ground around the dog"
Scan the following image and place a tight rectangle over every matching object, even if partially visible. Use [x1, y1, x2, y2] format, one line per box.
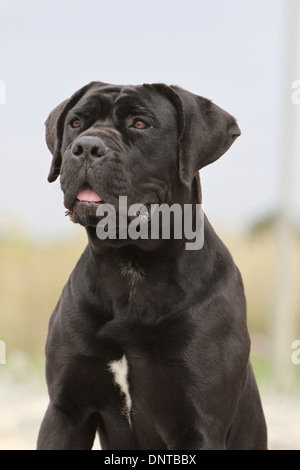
[0, 0, 300, 449]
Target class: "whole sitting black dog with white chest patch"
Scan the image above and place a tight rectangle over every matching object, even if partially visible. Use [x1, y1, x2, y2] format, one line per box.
[38, 82, 267, 450]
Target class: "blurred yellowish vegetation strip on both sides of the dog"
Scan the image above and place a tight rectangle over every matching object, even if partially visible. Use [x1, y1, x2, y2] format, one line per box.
[0, 226, 300, 382]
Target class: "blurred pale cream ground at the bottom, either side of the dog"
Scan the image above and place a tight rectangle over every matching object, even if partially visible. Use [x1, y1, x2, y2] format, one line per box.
[0, 370, 300, 450]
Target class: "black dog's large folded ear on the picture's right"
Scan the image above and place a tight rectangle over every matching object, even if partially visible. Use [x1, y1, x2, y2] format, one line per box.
[151, 84, 241, 188]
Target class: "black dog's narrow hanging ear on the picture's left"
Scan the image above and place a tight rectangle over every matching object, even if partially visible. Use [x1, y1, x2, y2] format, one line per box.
[45, 82, 104, 183]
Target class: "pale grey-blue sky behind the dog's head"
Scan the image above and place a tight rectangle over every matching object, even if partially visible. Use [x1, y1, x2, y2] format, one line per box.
[0, 0, 300, 238]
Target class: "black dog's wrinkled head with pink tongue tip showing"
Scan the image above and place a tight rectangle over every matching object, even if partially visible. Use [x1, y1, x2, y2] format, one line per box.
[46, 82, 240, 233]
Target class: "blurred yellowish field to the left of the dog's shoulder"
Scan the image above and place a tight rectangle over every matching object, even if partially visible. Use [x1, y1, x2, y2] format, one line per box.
[0, 234, 86, 358]
